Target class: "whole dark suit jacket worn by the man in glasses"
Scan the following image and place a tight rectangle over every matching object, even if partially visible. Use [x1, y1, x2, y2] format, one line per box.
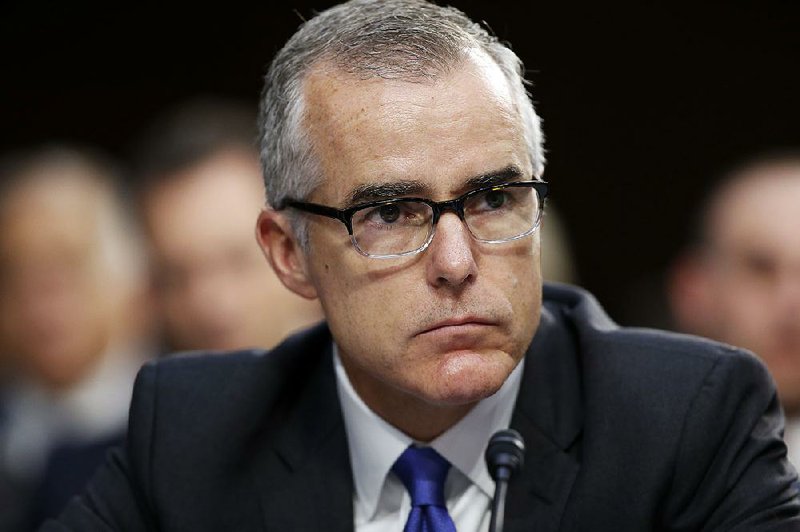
[46, 286, 800, 532]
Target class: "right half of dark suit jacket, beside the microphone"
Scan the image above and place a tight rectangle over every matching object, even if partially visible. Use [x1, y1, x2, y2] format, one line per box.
[509, 285, 800, 530]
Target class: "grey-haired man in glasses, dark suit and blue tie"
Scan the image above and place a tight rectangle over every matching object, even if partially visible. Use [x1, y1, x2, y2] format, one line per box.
[51, 1, 800, 531]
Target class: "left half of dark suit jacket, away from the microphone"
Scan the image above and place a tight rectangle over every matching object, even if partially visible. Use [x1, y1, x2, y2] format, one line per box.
[49, 325, 353, 531]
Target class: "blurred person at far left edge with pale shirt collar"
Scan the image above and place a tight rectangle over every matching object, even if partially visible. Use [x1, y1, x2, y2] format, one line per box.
[0, 147, 148, 531]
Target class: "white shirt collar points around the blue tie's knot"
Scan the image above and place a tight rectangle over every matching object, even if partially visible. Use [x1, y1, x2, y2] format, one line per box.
[333, 344, 524, 516]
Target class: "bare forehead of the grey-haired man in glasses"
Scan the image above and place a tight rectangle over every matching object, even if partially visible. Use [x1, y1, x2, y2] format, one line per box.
[304, 47, 530, 202]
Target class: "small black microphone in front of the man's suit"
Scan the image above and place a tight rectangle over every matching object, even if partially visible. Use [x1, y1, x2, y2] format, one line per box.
[485, 429, 525, 532]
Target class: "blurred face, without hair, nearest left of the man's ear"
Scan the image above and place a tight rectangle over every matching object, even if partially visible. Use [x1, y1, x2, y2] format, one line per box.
[142, 149, 319, 350]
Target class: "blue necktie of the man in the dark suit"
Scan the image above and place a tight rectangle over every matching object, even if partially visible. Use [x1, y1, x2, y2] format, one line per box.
[392, 446, 456, 532]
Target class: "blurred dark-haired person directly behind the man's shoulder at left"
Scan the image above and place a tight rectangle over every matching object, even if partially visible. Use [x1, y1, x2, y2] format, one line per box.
[137, 100, 321, 351]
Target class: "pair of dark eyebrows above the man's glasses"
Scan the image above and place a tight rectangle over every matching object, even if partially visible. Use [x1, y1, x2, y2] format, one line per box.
[344, 164, 523, 208]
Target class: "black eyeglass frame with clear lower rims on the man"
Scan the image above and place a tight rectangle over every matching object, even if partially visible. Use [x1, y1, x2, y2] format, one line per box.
[279, 180, 550, 259]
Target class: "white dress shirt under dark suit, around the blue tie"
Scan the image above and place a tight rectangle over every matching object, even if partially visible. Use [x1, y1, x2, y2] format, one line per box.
[333, 345, 524, 532]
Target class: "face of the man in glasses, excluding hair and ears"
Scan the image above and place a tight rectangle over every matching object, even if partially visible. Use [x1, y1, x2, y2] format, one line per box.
[296, 53, 541, 414]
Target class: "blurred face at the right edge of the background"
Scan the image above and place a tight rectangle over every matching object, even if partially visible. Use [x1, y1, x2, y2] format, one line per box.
[708, 174, 800, 411]
